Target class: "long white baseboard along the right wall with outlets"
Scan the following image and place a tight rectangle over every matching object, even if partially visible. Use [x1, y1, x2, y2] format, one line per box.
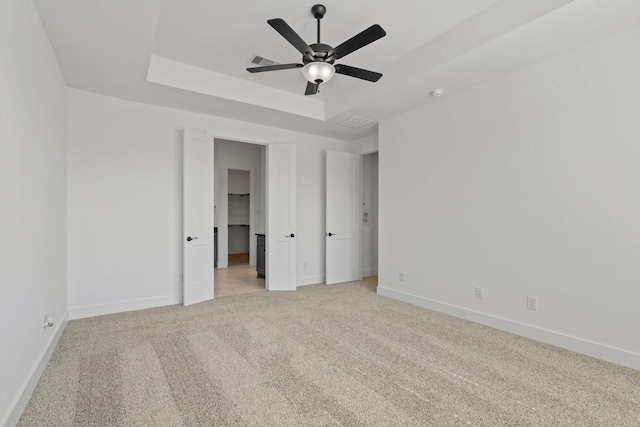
[378, 286, 640, 370]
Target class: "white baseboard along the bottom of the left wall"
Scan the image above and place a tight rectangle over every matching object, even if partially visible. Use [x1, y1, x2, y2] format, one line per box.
[0, 311, 69, 427]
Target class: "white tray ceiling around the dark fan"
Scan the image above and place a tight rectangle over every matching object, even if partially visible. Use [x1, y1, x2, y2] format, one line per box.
[34, 0, 640, 140]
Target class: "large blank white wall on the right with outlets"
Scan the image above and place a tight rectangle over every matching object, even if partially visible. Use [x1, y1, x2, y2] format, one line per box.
[380, 27, 640, 369]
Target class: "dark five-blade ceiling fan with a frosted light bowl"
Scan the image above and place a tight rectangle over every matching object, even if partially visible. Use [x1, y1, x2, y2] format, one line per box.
[247, 4, 387, 95]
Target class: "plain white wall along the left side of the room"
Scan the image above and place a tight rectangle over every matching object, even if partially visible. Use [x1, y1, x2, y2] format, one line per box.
[0, 0, 67, 425]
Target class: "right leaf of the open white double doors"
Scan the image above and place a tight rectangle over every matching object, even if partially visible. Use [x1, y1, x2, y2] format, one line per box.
[265, 144, 297, 291]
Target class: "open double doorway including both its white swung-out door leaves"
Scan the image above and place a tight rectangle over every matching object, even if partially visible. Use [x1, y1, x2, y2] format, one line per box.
[182, 129, 297, 305]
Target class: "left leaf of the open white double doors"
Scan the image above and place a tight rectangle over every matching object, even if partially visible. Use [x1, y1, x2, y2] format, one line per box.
[182, 129, 214, 305]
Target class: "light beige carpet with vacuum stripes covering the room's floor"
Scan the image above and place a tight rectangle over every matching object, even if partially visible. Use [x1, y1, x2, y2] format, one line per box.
[20, 282, 640, 426]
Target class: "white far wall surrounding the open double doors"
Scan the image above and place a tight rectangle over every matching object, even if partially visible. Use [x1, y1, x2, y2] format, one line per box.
[68, 89, 360, 317]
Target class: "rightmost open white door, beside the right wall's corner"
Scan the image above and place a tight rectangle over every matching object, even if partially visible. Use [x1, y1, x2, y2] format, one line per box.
[325, 150, 362, 284]
